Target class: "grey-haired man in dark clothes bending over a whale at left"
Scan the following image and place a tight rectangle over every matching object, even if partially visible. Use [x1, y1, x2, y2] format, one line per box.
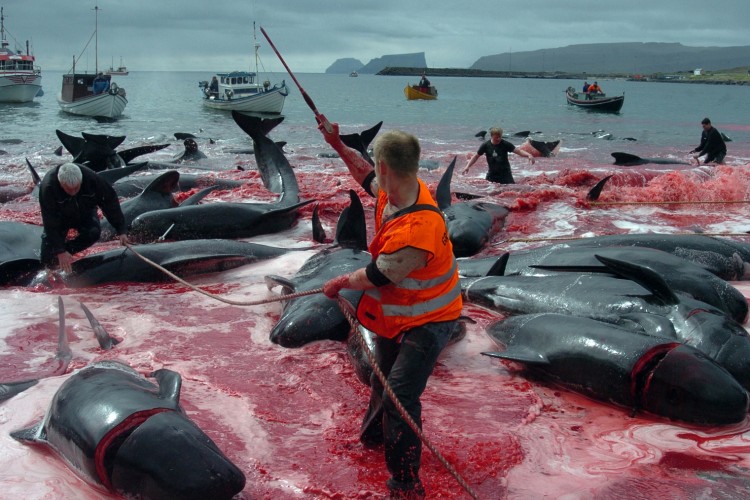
[39, 163, 129, 272]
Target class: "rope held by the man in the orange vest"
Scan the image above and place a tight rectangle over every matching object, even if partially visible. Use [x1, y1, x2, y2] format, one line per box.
[125, 243, 479, 500]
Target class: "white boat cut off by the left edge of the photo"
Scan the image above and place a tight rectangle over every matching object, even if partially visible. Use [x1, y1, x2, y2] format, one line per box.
[0, 7, 42, 102]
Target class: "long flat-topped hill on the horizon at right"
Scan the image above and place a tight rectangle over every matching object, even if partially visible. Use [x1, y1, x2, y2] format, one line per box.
[470, 42, 750, 74]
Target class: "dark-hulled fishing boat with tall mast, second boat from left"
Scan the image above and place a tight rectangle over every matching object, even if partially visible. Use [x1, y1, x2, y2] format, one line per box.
[57, 6, 128, 120]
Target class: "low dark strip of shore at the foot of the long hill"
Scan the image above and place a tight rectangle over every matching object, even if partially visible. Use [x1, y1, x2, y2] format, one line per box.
[375, 66, 750, 85]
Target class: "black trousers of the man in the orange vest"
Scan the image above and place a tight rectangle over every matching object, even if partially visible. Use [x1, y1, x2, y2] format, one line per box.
[360, 321, 456, 483]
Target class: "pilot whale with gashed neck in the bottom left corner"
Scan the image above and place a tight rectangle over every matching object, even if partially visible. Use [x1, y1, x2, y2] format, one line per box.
[11, 361, 245, 500]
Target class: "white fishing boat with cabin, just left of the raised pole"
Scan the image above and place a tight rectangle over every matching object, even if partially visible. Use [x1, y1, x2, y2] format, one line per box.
[198, 25, 289, 114]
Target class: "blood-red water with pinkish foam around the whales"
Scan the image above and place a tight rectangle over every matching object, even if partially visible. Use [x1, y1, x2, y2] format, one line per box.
[0, 144, 750, 499]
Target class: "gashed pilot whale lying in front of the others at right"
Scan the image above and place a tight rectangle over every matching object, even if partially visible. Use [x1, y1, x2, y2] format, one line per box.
[482, 313, 748, 425]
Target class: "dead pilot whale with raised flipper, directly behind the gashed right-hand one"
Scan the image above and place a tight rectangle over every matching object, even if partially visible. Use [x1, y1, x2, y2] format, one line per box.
[461, 257, 750, 388]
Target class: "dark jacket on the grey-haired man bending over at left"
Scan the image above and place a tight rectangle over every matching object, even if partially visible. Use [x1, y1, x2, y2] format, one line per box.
[39, 165, 127, 253]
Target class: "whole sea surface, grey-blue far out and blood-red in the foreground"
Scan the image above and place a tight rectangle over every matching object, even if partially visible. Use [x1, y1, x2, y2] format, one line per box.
[0, 71, 750, 500]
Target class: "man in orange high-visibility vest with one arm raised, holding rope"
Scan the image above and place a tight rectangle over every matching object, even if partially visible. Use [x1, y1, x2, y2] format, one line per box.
[318, 116, 462, 498]
